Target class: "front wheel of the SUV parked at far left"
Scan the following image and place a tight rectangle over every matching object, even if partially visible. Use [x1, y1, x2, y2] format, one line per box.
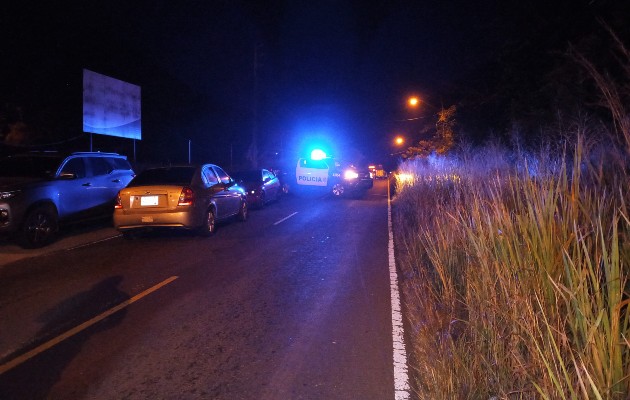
[18, 206, 59, 249]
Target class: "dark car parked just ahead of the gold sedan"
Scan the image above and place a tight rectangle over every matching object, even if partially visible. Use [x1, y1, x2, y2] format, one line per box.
[232, 168, 282, 207]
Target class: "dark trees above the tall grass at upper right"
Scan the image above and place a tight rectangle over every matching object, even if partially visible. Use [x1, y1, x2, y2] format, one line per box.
[448, 1, 630, 147]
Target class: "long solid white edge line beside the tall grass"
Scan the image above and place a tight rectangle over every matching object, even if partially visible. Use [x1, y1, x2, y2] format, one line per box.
[387, 185, 410, 400]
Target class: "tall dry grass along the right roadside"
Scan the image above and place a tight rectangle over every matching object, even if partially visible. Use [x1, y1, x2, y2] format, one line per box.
[393, 136, 630, 399]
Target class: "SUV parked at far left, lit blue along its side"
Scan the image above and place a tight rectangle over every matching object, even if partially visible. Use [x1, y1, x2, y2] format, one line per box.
[0, 152, 135, 248]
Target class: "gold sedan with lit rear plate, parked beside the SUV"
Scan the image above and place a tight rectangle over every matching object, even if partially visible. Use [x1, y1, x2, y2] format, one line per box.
[114, 164, 248, 236]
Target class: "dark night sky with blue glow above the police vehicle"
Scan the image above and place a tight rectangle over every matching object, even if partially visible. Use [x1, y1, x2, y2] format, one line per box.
[0, 0, 630, 164]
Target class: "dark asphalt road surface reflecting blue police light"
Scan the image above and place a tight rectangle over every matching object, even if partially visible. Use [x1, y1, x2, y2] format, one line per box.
[0, 182, 402, 400]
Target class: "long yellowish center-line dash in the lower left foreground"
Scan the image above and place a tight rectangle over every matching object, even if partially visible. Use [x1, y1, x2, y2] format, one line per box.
[0, 276, 178, 375]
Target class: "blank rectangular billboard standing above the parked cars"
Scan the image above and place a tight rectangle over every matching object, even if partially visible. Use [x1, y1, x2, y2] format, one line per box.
[83, 69, 142, 140]
